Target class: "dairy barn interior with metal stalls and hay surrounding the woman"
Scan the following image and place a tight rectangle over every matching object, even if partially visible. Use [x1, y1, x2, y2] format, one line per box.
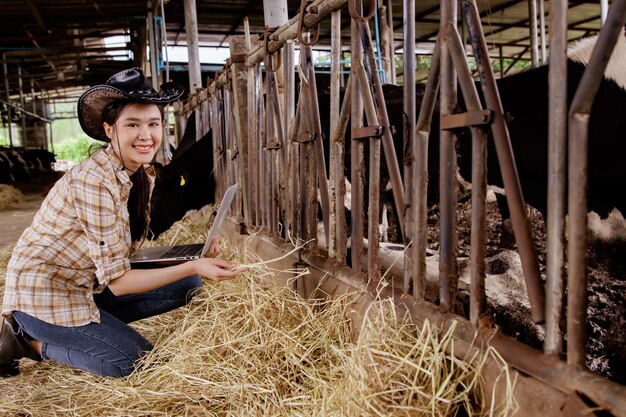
[0, 0, 626, 417]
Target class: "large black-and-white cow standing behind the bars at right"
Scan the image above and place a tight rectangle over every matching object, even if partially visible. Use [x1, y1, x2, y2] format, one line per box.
[346, 36, 626, 242]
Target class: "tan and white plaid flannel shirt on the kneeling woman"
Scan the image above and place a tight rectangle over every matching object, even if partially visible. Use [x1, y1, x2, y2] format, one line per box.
[2, 146, 154, 326]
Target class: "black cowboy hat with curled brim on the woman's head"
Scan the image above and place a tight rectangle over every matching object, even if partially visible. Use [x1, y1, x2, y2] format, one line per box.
[78, 68, 184, 142]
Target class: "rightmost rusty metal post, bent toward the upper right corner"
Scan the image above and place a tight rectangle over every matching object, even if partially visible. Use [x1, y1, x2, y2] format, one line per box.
[567, 0, 626, 368]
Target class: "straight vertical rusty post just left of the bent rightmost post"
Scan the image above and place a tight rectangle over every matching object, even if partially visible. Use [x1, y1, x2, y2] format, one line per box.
[544, 0, 567, 354]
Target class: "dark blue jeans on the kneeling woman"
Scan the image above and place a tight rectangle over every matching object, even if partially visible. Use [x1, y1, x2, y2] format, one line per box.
[13, 275, 202, 377]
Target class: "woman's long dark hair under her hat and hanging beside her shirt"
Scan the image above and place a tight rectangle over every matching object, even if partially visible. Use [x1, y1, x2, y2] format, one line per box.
[102, 100, 164, 241]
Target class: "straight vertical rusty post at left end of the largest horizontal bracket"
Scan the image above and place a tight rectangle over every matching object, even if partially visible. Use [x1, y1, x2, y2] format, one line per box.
[439, 0, 458, 311]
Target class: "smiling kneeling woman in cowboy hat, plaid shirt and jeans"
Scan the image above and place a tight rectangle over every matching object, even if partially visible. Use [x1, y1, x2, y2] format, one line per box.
[0, 68, 241, 377]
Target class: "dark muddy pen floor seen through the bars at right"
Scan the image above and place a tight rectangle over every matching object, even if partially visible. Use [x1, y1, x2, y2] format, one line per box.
[429, 190, 626, 384]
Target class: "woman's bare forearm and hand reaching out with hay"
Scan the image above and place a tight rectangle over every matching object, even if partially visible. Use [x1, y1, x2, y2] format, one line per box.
[109, 258, 244, 296]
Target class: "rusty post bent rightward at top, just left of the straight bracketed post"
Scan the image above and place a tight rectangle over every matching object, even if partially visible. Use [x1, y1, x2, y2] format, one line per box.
[412, 38, 441, 300]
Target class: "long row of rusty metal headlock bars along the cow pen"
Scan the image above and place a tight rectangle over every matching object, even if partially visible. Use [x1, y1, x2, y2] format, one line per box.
[173, 0, 626, 415]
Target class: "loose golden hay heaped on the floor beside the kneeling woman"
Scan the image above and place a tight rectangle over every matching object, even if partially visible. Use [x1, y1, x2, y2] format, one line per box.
[0, 206, 514, 416]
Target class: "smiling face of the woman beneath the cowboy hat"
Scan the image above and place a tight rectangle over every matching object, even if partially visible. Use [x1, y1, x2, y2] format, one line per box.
[104, 103, 163, 172]
